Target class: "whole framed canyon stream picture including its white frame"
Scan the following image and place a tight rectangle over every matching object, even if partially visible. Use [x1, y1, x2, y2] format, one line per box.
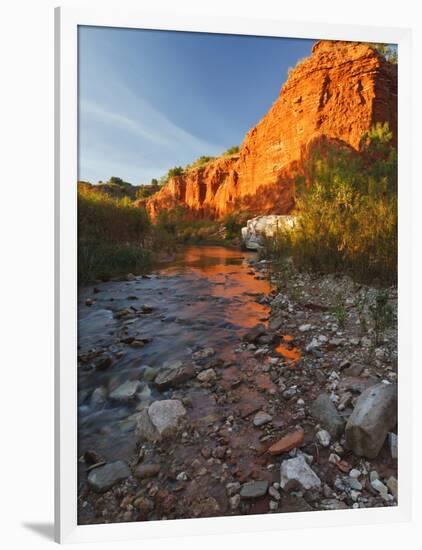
[55, 7, 411, 542]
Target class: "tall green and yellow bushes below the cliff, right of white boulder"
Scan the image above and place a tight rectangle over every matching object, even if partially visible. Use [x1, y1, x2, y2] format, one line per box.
[265, 124, 397, 284]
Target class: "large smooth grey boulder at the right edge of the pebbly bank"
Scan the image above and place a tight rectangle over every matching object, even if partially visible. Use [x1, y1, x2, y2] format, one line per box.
[346, 383, 397, 458]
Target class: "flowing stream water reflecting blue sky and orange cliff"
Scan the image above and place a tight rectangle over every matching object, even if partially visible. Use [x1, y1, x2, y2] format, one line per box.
[78, 246, 271, 468]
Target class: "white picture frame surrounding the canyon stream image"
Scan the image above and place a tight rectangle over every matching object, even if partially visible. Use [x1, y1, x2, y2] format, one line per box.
[55, 4, 411, 543]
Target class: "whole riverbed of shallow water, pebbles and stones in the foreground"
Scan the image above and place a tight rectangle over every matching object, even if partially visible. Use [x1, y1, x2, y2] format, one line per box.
[78, 247, 397, 524]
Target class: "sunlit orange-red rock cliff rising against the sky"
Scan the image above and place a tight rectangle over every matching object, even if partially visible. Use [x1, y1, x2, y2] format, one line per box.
[147, 41, 397, 218]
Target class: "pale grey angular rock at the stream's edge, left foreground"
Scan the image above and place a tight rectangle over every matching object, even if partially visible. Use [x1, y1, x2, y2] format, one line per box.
[136, 399, 186, 441]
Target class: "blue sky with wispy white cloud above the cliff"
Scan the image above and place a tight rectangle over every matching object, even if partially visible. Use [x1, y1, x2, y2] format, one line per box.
[78, 27, 314, 184]
